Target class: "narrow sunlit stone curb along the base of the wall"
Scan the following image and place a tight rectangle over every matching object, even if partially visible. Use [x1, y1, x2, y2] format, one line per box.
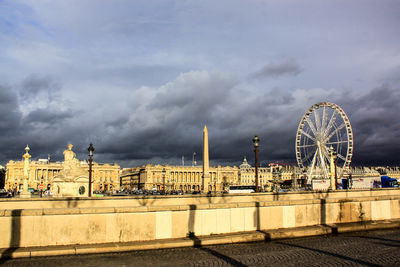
[0, 220, 400, 259]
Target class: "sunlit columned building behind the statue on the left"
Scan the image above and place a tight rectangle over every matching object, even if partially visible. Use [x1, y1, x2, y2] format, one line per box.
[4, 147, 120, 191]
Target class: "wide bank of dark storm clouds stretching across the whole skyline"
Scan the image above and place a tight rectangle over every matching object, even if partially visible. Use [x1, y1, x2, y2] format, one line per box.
[0, 71, 400, 167]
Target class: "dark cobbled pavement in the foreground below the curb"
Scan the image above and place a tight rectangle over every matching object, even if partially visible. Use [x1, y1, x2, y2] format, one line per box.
[1, 229, 400, 266]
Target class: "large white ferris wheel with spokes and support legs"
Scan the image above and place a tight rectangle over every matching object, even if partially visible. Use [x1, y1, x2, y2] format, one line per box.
[296, 102, 353, 183]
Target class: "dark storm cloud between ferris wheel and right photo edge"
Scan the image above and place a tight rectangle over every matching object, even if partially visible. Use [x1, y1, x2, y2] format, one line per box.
[343, 84, 400, 165]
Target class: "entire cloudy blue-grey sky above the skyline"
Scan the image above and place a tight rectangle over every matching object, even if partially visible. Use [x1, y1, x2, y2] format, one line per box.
[0, 0, 400, 167]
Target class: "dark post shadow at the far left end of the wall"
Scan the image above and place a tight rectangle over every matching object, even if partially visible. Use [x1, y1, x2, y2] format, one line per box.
[0, 210, 22, 264]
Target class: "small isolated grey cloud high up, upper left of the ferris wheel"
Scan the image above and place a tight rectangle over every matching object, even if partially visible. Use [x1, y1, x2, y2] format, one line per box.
[249, 59, 303, 79]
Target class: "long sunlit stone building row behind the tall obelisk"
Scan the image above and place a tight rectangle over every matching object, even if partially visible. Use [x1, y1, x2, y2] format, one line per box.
[121, 158, 299, 192]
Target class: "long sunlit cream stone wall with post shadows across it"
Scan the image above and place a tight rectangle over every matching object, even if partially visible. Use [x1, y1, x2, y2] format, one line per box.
[0, 189, 400, 248]
